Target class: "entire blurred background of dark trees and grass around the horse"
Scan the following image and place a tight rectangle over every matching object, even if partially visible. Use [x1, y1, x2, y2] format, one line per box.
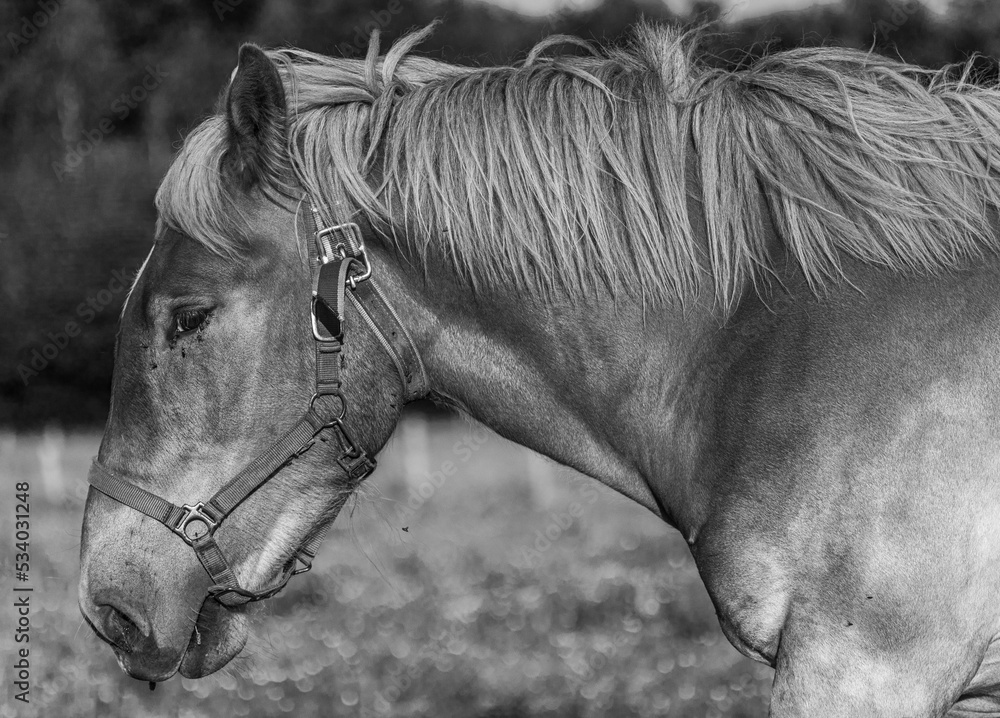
[0, 0, 1000, 718]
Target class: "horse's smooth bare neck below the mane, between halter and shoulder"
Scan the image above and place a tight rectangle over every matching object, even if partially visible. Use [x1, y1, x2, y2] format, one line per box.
[378, 250, 718, 530]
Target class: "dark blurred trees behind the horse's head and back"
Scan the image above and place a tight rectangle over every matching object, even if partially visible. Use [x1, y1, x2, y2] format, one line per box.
[0, 0, 1000, 428]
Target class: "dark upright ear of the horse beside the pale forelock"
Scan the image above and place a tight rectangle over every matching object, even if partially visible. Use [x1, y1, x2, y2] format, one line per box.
[224, 44, 286, 189]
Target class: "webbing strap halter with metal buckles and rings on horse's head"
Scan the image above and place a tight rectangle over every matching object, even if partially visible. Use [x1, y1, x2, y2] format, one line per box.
[88, 198, 427, 608]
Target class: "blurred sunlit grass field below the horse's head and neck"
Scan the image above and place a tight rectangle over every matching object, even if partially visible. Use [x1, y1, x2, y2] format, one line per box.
[0, 418, 772, 718]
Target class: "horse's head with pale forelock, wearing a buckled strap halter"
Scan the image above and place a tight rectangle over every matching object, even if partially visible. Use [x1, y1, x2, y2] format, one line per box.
[80, 46, 422, 681]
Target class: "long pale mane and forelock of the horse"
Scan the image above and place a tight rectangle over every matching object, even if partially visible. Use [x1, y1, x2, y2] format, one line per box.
[156, 25, 1000, 309]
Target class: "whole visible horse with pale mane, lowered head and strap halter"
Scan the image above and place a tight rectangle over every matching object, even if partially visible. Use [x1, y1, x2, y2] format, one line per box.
[80, 27, 1000, 718]
